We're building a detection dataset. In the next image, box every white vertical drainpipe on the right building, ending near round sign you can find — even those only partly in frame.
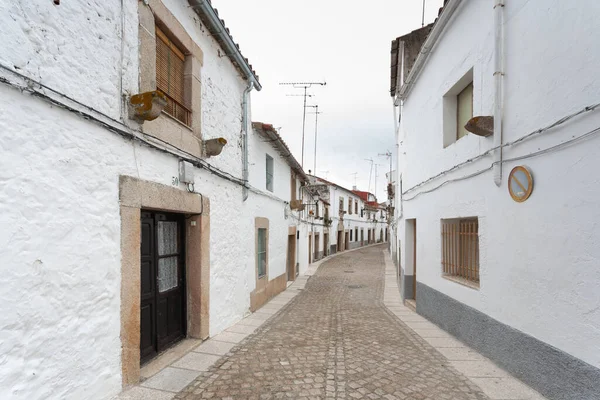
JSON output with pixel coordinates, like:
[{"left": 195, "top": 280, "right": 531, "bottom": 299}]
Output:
[{"left": 494, "top": 0, "right": 505, "bottom": 187}]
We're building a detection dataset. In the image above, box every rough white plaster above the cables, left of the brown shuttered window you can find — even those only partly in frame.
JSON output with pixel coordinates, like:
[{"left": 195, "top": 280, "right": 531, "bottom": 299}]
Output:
[{"left": 0, "top": 0, "right": 137, "bottom": 118}]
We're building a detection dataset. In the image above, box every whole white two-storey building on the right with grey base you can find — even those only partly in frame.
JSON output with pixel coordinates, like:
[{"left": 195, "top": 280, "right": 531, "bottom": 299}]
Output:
[{"left": 391, "top": 0, "right": 600, "bottom": 400}]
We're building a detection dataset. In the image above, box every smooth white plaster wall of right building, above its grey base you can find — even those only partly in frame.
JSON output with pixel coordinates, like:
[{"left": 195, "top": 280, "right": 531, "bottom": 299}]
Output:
[{"left": 398, "top": 0, "right": 600, "bottom": 367}]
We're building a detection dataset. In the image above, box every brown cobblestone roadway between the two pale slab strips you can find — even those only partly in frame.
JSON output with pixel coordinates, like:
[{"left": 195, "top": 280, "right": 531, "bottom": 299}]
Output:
[{"left": 175, "top": 246, "right": 487, "bottom": 400}]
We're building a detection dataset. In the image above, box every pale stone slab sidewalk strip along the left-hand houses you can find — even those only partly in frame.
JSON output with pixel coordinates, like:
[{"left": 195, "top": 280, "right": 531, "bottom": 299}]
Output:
[{"left": 113, "top": 275, "right": 310, "bottom": 400}]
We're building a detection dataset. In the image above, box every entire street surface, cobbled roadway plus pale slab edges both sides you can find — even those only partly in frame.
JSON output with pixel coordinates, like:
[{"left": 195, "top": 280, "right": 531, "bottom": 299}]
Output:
[{"left": 120, "top": 246, "right": 543, "bottom": 400}]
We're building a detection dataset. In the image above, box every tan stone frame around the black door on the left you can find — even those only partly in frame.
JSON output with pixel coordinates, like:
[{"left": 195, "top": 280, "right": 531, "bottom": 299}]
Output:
[{"left": 119, "top": 175, "right": 210, "bottom": 387}]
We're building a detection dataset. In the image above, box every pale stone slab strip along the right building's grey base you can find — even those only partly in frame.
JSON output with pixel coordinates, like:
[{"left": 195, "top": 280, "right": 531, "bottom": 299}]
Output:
[{"left": 383, "top": 251, "right": 545, "bottom": 400}]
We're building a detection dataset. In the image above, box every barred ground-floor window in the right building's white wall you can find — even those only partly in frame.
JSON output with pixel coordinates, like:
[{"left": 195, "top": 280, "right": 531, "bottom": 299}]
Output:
[{"left": 442, "top": 218, "right": 479, "bottom": 283}]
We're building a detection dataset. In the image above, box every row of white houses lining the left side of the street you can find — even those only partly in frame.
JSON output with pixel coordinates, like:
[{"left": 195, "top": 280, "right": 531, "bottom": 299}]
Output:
[{"left": 0, "top": 0, "right": 387, "bottom": 400}]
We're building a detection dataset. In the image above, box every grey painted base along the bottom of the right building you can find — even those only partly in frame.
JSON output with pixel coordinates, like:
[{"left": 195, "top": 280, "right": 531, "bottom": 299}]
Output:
[{"left": 420, "top": 282, "right": 600, "bottom": 400}]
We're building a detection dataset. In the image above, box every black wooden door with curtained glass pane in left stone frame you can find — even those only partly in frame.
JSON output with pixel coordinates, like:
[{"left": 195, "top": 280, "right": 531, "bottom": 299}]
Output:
[{"left": 140, "top": 211, "right": 186, "bottom": 362}]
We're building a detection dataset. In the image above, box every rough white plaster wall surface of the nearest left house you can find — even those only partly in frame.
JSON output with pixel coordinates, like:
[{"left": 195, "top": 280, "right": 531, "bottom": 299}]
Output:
[{"left": 0, "top": 0, "right": 282, "bottom": 400}]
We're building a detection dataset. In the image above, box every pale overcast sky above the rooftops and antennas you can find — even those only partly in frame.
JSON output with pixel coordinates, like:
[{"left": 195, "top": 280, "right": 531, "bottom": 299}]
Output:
[{"left": 212, "top": 0, "right": 443, "bottom": 202}]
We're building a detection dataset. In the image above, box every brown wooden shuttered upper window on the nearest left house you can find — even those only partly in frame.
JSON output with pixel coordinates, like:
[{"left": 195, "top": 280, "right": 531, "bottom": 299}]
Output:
[{"left": 156, "top": 27, "right": 191, "bottom": 126}]
